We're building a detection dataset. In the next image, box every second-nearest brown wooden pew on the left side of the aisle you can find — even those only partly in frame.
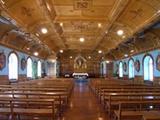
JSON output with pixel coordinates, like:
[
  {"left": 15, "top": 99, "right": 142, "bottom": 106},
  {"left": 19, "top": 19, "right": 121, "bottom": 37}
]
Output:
[{"left": 0, "top": 91, "right": 69, "bottom": 114}]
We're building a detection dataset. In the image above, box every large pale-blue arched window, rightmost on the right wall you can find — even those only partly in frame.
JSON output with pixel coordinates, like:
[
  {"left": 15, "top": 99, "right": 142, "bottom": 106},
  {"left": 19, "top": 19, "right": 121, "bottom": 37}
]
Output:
[{"left": 143, "top": 55, "right": 153, "bottom": 81}]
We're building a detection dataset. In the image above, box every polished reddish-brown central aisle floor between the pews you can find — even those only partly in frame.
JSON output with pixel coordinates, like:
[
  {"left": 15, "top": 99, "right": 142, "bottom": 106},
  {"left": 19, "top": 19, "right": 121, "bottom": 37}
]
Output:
[{"left": 62, "top": 82, "right": 109, "bottom": 120}]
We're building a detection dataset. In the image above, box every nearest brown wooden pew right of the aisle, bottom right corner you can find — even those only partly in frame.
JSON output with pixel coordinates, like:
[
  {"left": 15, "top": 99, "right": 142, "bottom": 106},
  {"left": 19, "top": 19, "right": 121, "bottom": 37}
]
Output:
[{"left": 114, "top": 100, "right": 160, "bottom": 120}]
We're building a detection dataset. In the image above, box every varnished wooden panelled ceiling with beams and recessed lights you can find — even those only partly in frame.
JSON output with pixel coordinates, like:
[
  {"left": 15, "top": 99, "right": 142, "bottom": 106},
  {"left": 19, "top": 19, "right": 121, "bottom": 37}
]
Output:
[{"left": 0, "top": 0, "right": 160, "bottom": 59}]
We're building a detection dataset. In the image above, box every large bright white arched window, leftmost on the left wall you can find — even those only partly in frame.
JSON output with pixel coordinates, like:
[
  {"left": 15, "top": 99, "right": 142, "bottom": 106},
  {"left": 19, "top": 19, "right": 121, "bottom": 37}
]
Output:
[{"left": 8, "top": 53, "right": 18, "bottom": 79}]
